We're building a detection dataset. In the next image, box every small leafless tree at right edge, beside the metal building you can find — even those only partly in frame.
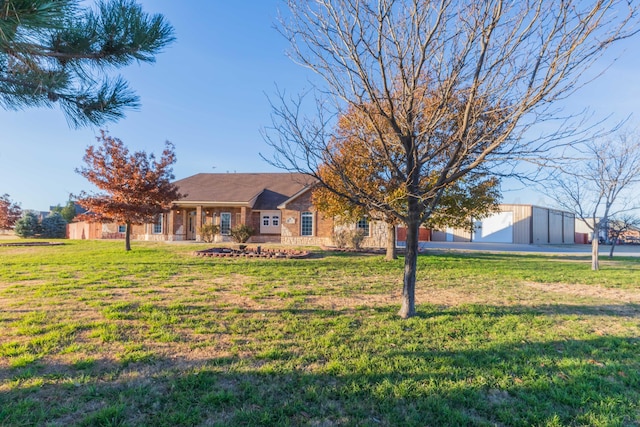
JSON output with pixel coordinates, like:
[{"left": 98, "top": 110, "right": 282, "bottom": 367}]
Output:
[{"left": 549, "top": 130, "right": 640, "bottom": 270}]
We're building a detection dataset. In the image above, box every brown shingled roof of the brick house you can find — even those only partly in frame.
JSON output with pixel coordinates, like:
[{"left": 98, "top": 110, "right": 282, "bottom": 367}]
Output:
[{"left": 175, "top": 173, "right": 314, "bottom": 210}]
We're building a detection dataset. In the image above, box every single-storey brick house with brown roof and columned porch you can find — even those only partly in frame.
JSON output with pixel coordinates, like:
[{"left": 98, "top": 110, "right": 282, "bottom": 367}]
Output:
[{"left": 67, "top": 173, "right": 386, "bottom": 247}]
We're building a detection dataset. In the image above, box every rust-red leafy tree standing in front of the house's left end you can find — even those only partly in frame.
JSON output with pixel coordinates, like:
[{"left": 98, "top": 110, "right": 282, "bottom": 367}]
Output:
[{"left": 76, "top": 130, "right": 183, "bottom": 251}]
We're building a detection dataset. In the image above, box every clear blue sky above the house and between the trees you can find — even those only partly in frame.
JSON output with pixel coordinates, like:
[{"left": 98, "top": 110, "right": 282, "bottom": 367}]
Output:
[{"left": 0, "top": 0, "right": 640, "bottom": 210}]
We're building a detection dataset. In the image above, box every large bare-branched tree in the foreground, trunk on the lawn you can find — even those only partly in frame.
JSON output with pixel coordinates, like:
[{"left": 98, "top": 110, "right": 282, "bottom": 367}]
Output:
[{"left": 265, "top": 0, "right": 638, "bottom": 317}]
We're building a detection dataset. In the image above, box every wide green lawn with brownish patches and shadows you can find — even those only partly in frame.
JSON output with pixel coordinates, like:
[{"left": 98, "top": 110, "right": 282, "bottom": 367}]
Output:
[{"left": 0, "top": 241, "right": 640, "bottom": 426}]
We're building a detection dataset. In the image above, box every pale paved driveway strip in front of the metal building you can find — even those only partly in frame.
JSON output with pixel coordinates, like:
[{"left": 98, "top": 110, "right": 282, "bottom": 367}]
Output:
[{"left": 410, "top": 242, "right": 640, "bottom": 258}]
